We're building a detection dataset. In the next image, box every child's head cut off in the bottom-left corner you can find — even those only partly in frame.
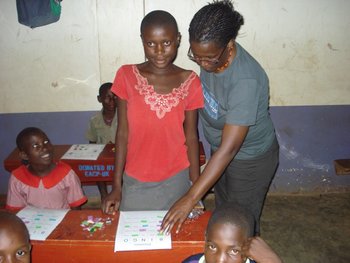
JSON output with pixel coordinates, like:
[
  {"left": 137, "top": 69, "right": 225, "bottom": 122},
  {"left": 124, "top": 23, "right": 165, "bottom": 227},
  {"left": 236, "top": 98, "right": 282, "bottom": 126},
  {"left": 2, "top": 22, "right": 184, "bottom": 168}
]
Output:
[{"left": 0, "top": 211, "right": 31, "bottom": 263}]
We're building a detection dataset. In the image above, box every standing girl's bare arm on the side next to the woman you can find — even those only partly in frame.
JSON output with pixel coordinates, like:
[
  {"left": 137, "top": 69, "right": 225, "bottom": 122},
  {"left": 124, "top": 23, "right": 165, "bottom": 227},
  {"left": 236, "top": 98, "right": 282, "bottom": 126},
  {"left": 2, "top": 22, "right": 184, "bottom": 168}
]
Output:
[{"left": 184, "top": 110, "right": 200, "bottom": 183}]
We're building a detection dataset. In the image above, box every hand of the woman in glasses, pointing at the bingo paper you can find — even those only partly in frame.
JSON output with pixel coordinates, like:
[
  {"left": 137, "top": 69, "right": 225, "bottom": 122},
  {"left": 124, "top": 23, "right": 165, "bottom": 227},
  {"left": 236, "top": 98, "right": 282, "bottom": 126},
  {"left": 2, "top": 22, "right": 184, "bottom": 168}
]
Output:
[{"left": 160, "top": 195, "right": 196, "bottom": 234}]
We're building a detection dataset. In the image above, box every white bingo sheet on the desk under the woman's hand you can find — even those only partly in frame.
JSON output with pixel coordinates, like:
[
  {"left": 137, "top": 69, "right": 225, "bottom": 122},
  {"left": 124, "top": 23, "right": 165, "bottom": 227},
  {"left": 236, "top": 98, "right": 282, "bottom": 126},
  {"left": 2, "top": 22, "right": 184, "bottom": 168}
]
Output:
[{"left": 114, "top": 211, "right": 171, "bottom": 251}]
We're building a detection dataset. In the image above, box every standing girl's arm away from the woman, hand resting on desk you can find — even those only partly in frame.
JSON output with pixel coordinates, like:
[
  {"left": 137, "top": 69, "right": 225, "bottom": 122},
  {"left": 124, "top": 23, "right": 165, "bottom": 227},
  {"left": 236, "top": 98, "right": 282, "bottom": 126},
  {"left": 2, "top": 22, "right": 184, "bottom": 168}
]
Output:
[{"left": 102, "top": 98, "right": 128, "bottom": 214}]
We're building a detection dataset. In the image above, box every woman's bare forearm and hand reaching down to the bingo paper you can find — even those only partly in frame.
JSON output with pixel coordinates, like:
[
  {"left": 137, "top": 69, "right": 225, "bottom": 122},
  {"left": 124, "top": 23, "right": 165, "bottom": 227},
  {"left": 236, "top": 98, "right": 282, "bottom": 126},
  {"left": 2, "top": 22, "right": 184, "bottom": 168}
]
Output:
[{"left": 161, "top": 124, "right": 249, "bottom": 233}]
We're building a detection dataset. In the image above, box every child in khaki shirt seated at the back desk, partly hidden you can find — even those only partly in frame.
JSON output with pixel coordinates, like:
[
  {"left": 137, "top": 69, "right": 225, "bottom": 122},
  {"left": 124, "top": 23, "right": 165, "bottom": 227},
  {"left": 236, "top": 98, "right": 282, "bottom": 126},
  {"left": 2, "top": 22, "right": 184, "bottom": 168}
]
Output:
[{"left": 86, "top": 82, "right": 118, "bottom": 200}]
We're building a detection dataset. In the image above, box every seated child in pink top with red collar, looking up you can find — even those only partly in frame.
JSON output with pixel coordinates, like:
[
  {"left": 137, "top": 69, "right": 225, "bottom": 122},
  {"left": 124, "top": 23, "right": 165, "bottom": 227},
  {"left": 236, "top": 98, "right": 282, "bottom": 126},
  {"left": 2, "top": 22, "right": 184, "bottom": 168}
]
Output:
[{"left": 6, "top": 127, "right": 87, "bottom": 210}]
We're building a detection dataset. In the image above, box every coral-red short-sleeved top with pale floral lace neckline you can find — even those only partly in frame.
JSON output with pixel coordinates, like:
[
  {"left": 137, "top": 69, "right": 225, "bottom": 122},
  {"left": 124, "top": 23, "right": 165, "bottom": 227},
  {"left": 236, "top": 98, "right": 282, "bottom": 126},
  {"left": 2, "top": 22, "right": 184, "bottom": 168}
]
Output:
[{"left": 112, "top": 65, "right": 204, "bottom": 182}]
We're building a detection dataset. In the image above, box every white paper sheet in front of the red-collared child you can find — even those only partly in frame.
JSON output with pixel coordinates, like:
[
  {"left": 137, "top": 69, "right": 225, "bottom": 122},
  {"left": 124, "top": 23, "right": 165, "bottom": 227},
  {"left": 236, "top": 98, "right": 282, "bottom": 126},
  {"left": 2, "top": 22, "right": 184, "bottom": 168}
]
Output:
[{"left": 17, "top": 206, "right": 69, "bottom": 240}]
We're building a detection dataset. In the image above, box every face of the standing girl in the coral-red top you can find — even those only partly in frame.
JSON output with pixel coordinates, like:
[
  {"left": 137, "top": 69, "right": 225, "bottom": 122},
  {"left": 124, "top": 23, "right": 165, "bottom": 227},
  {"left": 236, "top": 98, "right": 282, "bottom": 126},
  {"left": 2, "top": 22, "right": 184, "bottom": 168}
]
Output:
[{"left": 141, "top": 25, "right": 180, "bottom": 69}]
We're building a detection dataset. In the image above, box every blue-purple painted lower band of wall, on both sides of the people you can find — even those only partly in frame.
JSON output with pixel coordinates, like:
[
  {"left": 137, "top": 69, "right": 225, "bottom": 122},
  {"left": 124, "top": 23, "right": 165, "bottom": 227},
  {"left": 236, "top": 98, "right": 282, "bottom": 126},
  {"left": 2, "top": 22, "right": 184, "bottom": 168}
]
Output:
[{"left": 0, "top": 105, "right": 350, "bottom": 194}]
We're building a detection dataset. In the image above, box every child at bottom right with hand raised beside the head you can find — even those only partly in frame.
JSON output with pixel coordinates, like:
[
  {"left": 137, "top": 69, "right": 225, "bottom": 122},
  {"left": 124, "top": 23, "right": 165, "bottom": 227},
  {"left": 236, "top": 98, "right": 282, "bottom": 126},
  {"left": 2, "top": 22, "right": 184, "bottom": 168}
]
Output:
[{"left": 183, "top": 203, "right": 282, "bottom": 263}]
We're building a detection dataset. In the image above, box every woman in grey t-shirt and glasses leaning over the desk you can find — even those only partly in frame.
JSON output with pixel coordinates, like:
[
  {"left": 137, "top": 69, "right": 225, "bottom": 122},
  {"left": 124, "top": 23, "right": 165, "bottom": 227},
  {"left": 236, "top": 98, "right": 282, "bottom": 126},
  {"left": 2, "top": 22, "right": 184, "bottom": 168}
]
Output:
[{"left": 162, "top": 0, "right": 279, "bottom": 234}]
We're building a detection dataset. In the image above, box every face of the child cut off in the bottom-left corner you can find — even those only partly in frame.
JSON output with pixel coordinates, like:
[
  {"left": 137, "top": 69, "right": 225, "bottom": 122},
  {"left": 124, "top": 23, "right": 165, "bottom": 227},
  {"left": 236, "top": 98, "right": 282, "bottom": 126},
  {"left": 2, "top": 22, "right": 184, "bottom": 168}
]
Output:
[{"left": 0, "top": 226, "right": 30, "bottom": 263}]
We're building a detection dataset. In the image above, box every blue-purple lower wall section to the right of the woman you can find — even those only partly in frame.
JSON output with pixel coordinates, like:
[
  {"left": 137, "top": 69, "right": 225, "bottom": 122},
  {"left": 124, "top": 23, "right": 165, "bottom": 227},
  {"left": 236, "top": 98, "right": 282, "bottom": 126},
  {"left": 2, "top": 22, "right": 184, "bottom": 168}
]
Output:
[{"left": 270, "top": 105, "right": 350, "bottom": 192}]
